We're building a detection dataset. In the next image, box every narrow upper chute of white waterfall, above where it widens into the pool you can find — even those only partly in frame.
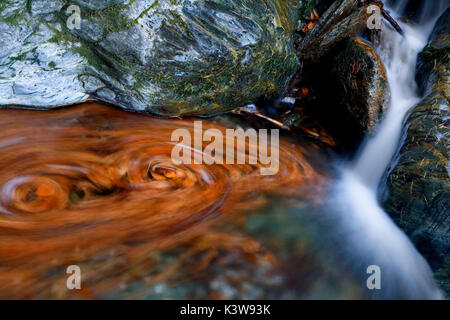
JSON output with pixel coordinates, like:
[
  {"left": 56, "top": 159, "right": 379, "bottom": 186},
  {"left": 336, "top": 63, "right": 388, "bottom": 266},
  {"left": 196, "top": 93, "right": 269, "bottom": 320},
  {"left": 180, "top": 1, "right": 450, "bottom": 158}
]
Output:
[{"left": 352, "top": 0, "right": 448, "bottom": 190}]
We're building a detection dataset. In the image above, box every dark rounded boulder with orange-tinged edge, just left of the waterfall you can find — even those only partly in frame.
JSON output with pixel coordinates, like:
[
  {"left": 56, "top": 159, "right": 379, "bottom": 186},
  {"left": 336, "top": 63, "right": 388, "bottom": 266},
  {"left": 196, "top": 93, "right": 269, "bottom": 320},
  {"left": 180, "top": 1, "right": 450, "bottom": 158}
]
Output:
[{"left": 282, "top": 37, "right": 390, "bottom": 151}]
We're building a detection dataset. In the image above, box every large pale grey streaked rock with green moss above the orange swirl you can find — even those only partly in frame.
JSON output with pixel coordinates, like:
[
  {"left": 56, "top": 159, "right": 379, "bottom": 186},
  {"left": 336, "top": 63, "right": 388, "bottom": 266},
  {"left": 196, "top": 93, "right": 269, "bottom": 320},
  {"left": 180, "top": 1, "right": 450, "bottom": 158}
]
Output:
[{"left": 0, "top": 0, "right": 308, "bottom": 116}]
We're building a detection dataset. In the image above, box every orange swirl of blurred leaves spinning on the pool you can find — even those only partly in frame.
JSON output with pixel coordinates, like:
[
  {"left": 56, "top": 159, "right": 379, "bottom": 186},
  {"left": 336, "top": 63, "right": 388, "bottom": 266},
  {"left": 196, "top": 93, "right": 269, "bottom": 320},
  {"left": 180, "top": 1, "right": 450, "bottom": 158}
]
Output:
[{"left": 0, "top": 104, "right": 321, "bottom": 298}]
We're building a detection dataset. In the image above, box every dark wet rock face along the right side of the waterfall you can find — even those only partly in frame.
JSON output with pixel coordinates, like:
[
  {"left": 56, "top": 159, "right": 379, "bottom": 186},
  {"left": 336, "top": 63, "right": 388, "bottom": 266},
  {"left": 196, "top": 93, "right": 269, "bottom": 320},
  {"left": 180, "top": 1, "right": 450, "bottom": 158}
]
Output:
[{"left": 384, "top": 9, "right": 450, "bottom": 294}]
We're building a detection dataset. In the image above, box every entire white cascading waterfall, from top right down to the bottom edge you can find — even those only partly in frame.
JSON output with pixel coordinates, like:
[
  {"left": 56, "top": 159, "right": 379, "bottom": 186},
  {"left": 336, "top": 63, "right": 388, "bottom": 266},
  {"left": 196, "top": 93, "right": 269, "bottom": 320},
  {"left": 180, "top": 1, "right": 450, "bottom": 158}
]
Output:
[{"left": 329, "top": 0, "right": 448, "bottom": 299}]
